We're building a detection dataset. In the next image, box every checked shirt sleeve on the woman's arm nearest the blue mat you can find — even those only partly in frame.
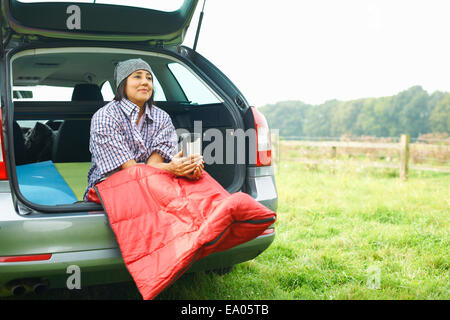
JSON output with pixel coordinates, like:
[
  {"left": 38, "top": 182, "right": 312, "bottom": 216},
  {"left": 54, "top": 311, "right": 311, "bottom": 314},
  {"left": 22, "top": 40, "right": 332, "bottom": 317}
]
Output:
[{"left": 89, "top": 109, "right": 133, "bottom": 175}]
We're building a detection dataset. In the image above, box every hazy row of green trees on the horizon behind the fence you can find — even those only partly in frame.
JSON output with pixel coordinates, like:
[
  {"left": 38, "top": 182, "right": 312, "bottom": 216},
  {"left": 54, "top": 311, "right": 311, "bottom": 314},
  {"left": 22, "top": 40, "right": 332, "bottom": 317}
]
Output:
[{"left": 258, "top": 86, "right": 450, "bottom": 138}]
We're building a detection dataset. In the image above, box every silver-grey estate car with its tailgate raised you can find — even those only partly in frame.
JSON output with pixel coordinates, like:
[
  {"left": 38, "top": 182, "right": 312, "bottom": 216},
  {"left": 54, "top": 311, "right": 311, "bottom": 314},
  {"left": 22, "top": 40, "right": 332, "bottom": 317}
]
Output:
[{"left": 0, "top": 0, "right": 277, "bottom": 297}]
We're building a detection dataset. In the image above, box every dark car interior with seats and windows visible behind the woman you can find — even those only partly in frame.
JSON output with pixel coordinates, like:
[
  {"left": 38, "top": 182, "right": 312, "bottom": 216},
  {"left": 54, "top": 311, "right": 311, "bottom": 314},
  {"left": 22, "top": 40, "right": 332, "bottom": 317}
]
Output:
[{"left": 12, "top": 48, "right": 236, "bottom": 206}]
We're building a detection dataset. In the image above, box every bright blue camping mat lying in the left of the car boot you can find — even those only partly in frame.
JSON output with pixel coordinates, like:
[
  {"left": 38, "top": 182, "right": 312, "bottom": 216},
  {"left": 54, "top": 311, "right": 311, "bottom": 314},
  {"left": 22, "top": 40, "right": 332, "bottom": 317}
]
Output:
[{"left": 16, "top": 161, "right": 77, "bottom": 205}]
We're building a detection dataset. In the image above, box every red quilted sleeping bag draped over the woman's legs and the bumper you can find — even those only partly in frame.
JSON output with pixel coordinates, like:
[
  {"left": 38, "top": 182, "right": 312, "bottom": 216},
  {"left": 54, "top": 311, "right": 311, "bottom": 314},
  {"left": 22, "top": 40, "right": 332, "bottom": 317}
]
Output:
[{"left": 88, "top": 164, "right": 276, "bottom": 299}]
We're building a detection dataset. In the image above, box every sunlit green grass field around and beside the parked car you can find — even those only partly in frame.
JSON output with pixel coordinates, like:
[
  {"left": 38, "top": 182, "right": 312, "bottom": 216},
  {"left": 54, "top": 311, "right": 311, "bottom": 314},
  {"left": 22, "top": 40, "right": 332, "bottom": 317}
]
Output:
[{"left": 7, "top": 162, "right": 450, "bottom": 300}]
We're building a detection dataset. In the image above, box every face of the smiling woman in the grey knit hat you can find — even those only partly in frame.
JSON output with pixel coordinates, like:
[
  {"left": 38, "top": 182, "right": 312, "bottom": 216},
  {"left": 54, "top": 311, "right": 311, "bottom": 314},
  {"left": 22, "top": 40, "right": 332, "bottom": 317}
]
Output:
[{"left": 125, "top": 70, "right": 153, "bottom": 107}]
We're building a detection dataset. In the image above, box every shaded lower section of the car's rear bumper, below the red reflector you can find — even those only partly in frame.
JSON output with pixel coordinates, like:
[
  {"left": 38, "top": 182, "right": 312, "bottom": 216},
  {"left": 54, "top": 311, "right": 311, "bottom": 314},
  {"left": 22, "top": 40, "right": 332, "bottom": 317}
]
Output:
[{"left": 0, "top": 232, "right": 275, "bottom": 297}]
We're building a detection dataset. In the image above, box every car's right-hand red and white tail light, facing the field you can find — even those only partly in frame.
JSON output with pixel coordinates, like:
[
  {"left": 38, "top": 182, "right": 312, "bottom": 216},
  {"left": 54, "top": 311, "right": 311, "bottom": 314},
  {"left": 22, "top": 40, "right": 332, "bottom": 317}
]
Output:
[{"left": 251, "top": 107, "right": 272, "bottom": 167}]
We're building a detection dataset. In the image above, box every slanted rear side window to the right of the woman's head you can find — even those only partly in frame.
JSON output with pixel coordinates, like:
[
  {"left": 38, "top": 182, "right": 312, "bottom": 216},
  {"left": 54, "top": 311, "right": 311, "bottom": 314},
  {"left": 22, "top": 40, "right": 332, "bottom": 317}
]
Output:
[{"left": 168, "top": 62, "right": 222, "bottom": 105}]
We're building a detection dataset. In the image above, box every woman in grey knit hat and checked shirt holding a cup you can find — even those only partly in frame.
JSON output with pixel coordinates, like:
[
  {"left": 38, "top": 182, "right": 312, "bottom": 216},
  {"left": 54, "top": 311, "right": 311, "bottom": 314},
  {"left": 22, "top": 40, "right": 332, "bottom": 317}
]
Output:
[{"left": 84, "top": 59, "right": 204, "bottom": 201}]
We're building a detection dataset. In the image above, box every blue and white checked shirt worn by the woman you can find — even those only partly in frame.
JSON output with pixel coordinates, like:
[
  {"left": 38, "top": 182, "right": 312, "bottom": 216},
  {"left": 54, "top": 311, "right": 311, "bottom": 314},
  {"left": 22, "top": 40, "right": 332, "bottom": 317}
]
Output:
[{"left": 84, "top": 99, "right": 178, "bottom": 201}]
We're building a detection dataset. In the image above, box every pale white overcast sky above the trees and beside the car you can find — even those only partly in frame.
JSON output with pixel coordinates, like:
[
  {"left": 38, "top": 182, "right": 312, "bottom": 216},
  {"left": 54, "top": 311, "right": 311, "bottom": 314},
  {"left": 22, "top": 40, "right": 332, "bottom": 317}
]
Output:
[{"left": 184, "top": 0, "right": 450, "bottom": 106}]
